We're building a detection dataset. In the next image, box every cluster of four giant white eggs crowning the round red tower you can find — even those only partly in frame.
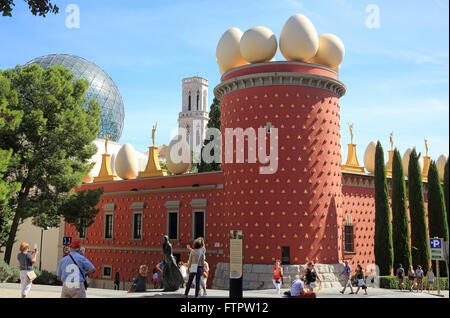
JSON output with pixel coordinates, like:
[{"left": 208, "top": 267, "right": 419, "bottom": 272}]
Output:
[{"left": 216, "top": 14, "right": 345, "bottom": 74}]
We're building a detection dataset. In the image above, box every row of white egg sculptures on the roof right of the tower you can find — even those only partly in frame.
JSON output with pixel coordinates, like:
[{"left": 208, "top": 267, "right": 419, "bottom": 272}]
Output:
[{"left": 364, "top": 141, "right": 448, "bottom": 181}]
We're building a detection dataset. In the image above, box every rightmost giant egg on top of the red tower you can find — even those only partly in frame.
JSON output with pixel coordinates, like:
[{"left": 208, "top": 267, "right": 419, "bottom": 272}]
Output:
[{"left": 308, "top": 33, "right": 345, "bottom": 68}]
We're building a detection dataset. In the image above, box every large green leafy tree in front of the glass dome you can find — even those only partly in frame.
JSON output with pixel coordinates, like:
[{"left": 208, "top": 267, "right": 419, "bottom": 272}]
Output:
[{"left": 0, "top": 64, "right": 101, "bottom": 263}]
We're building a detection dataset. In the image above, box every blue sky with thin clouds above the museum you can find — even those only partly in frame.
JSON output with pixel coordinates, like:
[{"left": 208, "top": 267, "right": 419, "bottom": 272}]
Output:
[{"left": 0, "top": 0, "right": 449, "bottom": 164}]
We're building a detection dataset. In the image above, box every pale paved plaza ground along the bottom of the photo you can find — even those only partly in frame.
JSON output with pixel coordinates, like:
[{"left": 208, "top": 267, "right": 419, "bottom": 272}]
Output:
[{"left": 0, "top": 283, "right": 449, "bottom": 299}]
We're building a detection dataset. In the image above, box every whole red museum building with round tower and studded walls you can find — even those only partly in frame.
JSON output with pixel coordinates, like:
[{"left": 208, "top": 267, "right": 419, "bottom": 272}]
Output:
[{"left": 65, "top": 62, "right": 428, "bottom": 287}]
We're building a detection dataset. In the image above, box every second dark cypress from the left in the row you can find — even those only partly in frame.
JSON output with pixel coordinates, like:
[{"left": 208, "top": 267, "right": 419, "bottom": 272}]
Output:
[{"left": 392, "top": 149, "right": 411, "bottom": 269}]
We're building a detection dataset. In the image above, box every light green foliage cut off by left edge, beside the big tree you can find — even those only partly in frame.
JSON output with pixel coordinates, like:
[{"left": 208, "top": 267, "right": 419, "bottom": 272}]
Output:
[{"left": 0, "top": 71, "right": 23, "bottom": 247}]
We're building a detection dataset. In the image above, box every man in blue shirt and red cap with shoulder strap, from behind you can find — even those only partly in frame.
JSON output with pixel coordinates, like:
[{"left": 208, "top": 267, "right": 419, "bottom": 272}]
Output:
[{"left": 56, "top": 241, "right": 95, "bottom": 298}]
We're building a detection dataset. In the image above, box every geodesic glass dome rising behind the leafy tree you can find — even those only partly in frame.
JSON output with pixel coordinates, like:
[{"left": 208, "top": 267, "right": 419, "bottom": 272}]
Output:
[{"left": 26, "top": 54, "right": 125, "bottom": 142}]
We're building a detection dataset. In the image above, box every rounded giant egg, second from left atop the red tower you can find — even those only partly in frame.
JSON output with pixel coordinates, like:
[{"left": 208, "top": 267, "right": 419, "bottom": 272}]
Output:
[{"left": 240, "top": 26, "right": 278, "bottom": 63}]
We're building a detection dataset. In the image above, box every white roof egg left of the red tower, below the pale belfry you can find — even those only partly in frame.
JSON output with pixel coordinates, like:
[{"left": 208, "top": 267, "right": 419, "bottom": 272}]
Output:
[{"left": 166, "top": 135, "right": 191, "bottom": 174}]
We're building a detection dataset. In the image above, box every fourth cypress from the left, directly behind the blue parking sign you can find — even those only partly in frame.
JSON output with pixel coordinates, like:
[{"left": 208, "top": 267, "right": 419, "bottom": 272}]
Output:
[{"left": 428, "top": 161, "right": 448, "bottom": 276}]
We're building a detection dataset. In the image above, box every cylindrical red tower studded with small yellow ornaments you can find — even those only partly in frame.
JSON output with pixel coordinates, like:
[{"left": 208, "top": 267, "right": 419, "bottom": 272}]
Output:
[{"left": 214, "top": 62, "right": 346, "bottom": 264}]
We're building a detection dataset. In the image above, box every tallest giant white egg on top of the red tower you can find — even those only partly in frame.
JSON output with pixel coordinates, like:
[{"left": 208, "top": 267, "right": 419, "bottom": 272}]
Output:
[{"left": 280, "top": 14, "right": 319, "bottom": 62}]
